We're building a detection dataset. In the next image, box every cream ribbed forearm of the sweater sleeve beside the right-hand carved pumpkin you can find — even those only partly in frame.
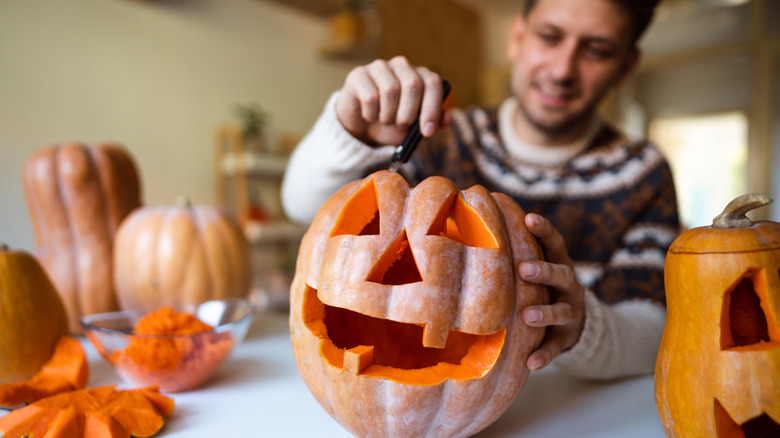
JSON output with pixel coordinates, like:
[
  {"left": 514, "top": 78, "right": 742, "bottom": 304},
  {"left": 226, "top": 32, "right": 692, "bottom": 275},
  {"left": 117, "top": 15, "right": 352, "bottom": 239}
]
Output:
[{"left": 553, "top": 290, "right": 666, "bottom": 380}]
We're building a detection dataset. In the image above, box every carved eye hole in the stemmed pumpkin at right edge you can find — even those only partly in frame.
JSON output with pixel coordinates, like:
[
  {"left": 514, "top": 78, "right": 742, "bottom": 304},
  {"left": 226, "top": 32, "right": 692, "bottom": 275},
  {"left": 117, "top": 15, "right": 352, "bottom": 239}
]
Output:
[{"left": 720, "top": 270, "right": 780, "bottom": 350}]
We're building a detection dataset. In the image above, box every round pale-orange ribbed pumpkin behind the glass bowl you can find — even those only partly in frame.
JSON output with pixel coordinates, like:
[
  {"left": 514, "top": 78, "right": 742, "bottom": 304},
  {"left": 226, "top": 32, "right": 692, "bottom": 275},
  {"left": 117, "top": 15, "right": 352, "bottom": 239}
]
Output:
[{"left": 114, "top": 198, "right": 252, "bottom": 311}]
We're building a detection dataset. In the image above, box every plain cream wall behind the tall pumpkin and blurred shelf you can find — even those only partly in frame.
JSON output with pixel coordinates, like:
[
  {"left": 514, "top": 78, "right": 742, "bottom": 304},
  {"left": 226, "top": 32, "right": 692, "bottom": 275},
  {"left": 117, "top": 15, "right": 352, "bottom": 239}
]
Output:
[{"left": 0, "top": 0, "right": 352, "bottom": 250}]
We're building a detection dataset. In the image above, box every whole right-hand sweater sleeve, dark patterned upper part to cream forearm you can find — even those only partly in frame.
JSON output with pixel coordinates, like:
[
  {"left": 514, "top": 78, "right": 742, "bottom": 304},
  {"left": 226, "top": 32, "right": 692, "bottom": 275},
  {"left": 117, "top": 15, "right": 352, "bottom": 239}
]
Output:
[{"left": 555, "top": 147, "right": 679, "bottom": 379}]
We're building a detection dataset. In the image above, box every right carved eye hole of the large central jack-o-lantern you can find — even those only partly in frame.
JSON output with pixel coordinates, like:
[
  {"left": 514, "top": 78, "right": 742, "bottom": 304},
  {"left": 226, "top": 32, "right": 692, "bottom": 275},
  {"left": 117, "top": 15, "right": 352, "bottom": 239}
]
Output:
[{"left": 427, "top": 192, "right": 498, "bottom": 248}]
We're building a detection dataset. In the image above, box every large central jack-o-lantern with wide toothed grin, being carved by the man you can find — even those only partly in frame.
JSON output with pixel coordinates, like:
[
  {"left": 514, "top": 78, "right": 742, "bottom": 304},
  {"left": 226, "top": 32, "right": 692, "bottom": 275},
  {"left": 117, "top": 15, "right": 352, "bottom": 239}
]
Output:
[{"left": 290, "top": 171, "right": 547, "bottom": 437}]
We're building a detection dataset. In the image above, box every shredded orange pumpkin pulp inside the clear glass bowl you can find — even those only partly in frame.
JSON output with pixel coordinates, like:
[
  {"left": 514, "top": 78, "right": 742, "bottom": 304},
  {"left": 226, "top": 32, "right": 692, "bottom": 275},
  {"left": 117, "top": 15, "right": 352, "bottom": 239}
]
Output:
[{"left": 111, "top": 307, "right": 233, "bottom": 392}]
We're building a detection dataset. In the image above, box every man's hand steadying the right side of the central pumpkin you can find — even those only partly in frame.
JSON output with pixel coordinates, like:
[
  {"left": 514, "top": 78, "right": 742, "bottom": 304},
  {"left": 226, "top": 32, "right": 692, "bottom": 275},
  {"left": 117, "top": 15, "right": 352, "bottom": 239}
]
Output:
[{"left": 520, "top": 213, "right": 585, "bottom": 370}]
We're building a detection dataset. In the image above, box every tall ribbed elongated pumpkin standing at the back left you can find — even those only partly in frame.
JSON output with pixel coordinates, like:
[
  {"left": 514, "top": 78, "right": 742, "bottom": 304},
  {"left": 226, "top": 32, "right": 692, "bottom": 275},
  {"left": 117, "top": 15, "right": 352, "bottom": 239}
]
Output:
[{"left": 24, "top": 142, "right": 141, "bottom": 333}]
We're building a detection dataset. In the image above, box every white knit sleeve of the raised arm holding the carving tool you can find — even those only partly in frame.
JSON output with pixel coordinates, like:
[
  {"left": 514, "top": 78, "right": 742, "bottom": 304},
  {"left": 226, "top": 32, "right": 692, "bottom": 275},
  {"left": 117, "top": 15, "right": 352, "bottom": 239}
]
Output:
[{"left": 281, "top": 91, "right": 395, "bottom": 224}]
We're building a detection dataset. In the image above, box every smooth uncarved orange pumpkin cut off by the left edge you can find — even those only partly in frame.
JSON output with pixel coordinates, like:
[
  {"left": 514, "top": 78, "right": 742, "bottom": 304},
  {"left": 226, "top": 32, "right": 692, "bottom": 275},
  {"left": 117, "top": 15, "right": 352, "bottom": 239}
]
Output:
[{"left": 0, "top": 244, "right": 68, "bottom": 384}]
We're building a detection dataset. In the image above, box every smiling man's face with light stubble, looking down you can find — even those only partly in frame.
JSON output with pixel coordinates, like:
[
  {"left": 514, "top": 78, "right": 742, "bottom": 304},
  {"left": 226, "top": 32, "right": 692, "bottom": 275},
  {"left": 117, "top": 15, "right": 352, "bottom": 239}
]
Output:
[{"left": 508, "top": 0, "right": 638, "bottom": 143}]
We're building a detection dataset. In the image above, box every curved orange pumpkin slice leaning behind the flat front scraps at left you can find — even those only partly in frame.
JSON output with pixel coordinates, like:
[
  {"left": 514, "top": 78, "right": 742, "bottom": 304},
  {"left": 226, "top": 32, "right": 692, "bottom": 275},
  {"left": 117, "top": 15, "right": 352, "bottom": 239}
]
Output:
[{"left": 0, "top": 336, "right": 89, "bottom": 406}]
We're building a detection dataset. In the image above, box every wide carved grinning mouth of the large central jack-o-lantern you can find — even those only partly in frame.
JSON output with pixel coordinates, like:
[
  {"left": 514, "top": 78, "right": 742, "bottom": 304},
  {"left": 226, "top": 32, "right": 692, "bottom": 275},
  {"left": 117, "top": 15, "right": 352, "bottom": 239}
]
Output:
[{"left": 302, "top": 285, "right": 506, "bottom": 385}]
